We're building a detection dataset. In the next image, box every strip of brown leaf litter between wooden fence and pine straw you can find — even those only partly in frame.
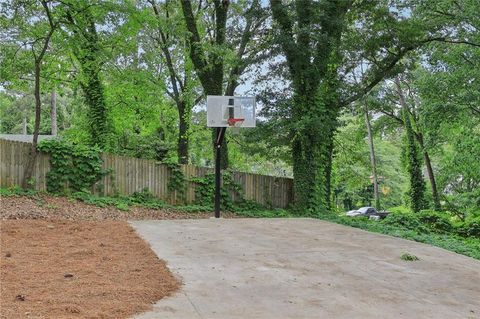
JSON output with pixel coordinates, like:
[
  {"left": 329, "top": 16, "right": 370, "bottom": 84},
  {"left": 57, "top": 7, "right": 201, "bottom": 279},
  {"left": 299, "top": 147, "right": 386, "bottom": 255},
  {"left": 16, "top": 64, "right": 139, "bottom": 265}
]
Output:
[{"left": 0, "top": 194, "right": 235, "bottom": 220}]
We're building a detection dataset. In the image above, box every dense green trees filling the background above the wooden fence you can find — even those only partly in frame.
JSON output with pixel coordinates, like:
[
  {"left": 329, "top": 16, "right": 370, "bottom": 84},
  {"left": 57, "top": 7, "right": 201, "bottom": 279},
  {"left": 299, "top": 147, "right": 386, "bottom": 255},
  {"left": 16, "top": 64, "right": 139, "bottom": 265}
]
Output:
[{"left": 0, "top": 0, "right": 480, "bottom": 216}]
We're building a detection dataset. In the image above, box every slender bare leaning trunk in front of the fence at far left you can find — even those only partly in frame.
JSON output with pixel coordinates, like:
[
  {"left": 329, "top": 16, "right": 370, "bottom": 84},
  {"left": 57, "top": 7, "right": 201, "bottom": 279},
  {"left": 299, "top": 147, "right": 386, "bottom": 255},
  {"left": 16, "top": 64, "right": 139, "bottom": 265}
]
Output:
[{"left": 22, "top": 60, "right": 42, "bottom": 188}]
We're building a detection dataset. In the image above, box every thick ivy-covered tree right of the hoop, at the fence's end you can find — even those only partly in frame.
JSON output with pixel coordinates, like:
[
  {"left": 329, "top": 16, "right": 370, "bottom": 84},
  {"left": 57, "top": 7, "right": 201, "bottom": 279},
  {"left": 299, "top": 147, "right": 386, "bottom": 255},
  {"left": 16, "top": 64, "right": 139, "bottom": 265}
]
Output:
[{"left": 270, "top": 0, "right": 433, "bottom": 214}]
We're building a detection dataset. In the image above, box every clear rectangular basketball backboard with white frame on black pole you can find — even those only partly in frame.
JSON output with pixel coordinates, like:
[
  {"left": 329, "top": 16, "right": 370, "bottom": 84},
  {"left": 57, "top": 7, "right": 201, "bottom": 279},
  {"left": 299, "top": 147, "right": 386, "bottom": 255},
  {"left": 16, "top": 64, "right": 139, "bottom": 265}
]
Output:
[{"left": 207, "top": 95, "right": 255, "bottom": 127}]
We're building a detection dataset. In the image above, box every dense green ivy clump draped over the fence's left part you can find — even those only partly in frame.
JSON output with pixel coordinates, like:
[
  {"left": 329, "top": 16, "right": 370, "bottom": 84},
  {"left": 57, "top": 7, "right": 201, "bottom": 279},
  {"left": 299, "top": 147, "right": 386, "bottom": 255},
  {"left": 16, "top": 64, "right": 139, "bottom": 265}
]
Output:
[{"left": 38, "top": 140, "right": 106, "bottom": 193}]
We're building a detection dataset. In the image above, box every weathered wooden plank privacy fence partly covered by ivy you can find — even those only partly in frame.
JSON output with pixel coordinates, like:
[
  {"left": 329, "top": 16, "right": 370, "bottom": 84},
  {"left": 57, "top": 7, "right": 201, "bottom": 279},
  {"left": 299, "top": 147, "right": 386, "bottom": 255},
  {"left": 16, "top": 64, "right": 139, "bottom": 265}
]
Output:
[{"left": 0, "top": 139, "right": 293, "bottom": 208}]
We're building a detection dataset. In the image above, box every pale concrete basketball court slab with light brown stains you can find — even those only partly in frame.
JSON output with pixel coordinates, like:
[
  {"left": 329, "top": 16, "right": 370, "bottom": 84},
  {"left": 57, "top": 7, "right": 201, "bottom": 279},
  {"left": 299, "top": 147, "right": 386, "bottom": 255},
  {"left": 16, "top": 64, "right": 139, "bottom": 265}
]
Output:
[{"left": 131, "top": 219, "right": 480, "bottom": 319}]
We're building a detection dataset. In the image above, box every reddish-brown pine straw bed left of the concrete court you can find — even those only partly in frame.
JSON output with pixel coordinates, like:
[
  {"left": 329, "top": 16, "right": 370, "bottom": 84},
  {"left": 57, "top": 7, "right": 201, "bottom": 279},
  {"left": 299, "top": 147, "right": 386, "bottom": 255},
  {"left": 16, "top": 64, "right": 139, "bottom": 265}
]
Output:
[{"left": 0, "top": 220, "right": 180, "bottom": 318}]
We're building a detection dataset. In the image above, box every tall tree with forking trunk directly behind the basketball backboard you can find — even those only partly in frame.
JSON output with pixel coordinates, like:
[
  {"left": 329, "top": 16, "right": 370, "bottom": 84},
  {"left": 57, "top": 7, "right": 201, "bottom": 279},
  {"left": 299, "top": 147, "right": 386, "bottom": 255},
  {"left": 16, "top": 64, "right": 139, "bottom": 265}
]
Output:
[{"left": 181, "top": 0, "right": 267, "bottom": 168}]
